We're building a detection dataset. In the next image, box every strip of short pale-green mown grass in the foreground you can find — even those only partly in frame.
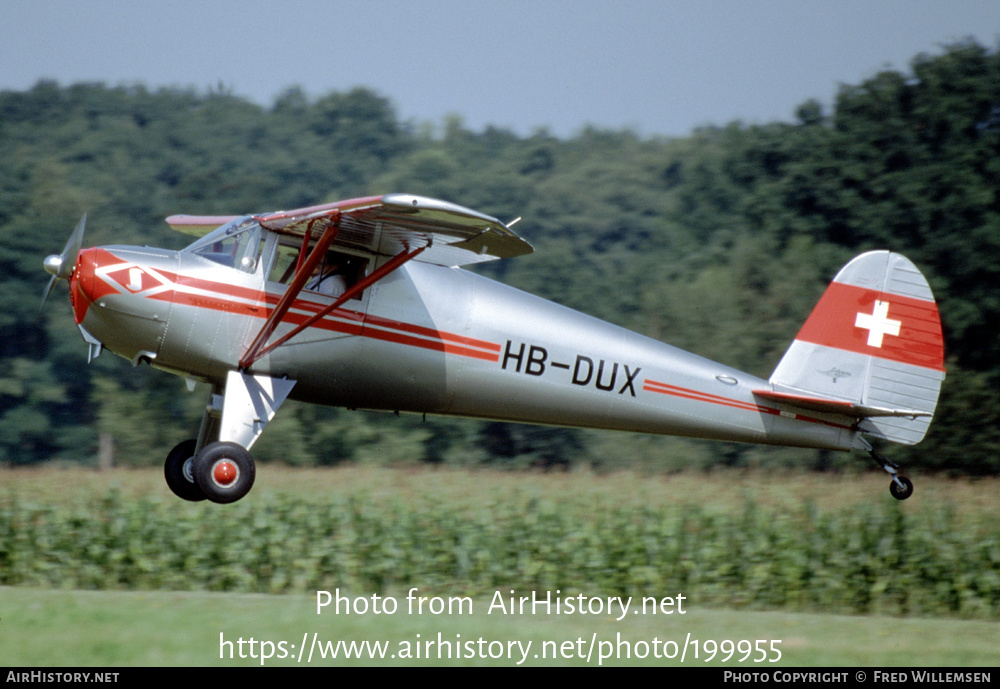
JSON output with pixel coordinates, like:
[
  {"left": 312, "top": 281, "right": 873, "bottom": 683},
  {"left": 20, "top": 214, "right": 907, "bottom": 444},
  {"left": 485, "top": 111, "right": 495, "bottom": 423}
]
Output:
[{"left": 0, "top": 588, "right": 1000, "bottom": 670}]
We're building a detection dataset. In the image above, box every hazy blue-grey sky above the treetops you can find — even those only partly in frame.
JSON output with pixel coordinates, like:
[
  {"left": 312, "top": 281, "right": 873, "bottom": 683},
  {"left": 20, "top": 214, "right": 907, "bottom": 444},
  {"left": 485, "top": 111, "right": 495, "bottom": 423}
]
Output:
[{"left": 0, "top": 0, "right": 1000, "bottom": 138}]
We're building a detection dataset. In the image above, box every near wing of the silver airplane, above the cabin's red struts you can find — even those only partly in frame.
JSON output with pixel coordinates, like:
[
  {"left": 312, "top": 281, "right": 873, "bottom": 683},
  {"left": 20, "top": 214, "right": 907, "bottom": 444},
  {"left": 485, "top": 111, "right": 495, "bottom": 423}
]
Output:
[{"left": 258, "top": 194, "right": 534, "bottom": 266}]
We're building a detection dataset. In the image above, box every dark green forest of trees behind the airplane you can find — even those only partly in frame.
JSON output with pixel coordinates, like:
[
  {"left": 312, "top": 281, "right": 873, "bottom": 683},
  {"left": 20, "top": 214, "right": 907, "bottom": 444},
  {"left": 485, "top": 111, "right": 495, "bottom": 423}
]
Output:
[{"left": 0, "top": 41, "right": 1000, "bottom": 475}]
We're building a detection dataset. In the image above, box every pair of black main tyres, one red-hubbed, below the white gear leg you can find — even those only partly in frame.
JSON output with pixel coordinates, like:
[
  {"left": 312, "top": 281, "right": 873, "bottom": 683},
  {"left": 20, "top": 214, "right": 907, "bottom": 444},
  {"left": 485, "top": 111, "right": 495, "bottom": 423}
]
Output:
[{"left": 163, "top": 438, "right": 257, "bottom": 503}]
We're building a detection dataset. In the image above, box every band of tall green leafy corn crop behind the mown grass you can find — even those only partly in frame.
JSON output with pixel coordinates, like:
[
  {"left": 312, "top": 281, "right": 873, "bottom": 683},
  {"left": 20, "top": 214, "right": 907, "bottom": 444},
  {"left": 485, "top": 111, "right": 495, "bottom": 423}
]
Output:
[{"left": 0, "top": 490, "right": 1000, "bottom": 618}]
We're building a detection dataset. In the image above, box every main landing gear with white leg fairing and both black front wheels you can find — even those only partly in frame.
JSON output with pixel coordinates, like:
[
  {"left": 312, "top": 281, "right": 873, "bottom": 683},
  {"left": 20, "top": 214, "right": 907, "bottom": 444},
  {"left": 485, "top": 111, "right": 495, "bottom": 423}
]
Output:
[{"left": 163, "top": 371, "right": 295, "bottom": 503}]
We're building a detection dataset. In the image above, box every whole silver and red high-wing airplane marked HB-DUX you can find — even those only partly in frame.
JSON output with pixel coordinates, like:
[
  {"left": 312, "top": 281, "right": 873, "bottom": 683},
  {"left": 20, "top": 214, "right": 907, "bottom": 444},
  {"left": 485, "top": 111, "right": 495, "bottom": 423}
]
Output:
[{"left": 45, "top": 194, "right": 945, "bottom": 503}]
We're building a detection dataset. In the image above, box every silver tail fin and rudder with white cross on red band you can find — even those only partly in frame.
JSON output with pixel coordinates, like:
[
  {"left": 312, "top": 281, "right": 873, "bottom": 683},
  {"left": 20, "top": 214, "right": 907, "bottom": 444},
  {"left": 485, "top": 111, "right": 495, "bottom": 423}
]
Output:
[{"left": 770, "top": 251, "right": 945, "bottom": 445}]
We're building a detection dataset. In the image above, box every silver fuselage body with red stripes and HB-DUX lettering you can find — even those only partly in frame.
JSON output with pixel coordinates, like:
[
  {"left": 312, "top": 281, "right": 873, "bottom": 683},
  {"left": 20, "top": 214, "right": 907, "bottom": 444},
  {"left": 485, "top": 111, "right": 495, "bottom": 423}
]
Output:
[{"left": 71, "top": 243, "right": 855, "bottom": 450}]
